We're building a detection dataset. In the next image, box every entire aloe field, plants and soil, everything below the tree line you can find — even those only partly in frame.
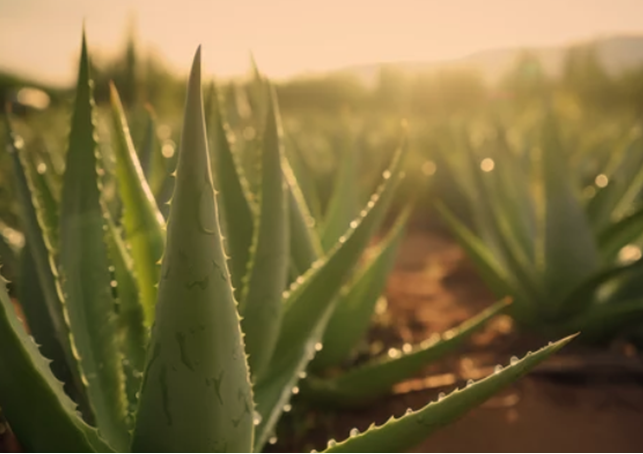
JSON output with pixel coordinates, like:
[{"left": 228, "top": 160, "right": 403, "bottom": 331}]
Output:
[{"left": 0, "top": 30, "right": 643, "bottom": 452}]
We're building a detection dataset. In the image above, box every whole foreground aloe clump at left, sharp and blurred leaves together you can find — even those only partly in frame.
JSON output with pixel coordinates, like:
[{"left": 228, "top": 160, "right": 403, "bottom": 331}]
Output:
[{"left": 0, "top": 33, "right": 577, "bottom": 452}]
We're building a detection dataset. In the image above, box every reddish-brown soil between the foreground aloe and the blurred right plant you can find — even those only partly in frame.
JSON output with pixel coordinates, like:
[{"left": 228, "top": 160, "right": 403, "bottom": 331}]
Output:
[{"left": 269, "top": 229, "right": 643, "bottom": 452}]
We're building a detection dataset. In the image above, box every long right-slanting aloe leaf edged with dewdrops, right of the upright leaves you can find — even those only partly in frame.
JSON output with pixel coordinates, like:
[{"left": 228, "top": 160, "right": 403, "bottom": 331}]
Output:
[{"left": 255, "top": 133, "right": 408, "bottom": 451}]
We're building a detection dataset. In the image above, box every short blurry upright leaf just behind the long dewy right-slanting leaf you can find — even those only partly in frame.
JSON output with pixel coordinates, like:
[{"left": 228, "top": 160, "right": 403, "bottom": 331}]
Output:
[{"left": 322, "top": 129, "right": 359, "bottom": 251}]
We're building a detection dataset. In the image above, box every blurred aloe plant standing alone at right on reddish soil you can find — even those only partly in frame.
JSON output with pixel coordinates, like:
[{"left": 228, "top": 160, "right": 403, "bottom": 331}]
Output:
[{"left": 438, "top": 111, "right": 643, "bottom": 342}]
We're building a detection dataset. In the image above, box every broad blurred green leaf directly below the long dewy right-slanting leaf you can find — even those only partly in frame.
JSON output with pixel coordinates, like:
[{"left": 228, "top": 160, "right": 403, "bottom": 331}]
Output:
[{"left": 311, "top": 206, "right": 411, "bottom": 370}]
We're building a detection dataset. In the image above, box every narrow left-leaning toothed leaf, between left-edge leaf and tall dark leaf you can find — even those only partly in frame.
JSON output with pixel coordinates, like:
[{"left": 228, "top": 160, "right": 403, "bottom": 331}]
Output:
[{"left": 6, "top": 113, "right": 92, "bottom": 414}]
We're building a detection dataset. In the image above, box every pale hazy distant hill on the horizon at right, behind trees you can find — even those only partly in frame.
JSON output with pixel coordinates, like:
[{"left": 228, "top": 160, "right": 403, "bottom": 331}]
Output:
[{"left": 333, "top": 36, "right": 643, "bottom": 85}]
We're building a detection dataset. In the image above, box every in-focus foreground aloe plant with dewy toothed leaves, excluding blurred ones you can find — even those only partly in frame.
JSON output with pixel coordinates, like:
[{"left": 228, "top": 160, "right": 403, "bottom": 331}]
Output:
[{"left": 0, "top": 32, "right": 569, "bottom": 452}]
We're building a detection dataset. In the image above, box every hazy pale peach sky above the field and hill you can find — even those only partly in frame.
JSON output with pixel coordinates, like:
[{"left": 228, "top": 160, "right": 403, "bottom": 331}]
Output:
[{"left": 0, "top": 0, "right": 643, "bottom": 83}]
